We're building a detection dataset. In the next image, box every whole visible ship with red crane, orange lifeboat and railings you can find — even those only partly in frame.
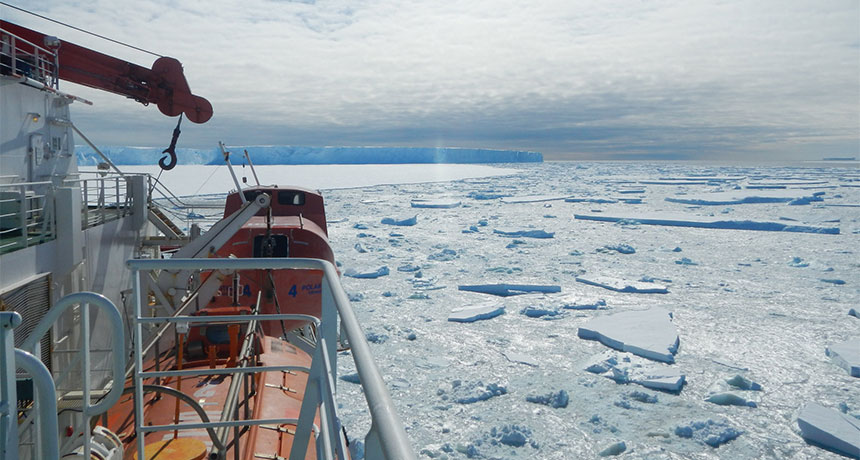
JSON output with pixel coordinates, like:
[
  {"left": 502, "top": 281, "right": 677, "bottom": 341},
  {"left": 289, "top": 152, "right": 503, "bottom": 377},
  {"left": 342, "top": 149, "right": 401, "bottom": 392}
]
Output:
[{"left": 0, "top": 21, "right": 414, "bottom": 459}]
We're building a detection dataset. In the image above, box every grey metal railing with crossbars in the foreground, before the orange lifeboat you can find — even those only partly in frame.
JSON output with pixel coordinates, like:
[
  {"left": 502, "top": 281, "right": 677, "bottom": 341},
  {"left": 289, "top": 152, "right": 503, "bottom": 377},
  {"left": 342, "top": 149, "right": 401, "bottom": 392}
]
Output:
[{"left": 128, "top": 258, "right": 415, "bottom": 460}]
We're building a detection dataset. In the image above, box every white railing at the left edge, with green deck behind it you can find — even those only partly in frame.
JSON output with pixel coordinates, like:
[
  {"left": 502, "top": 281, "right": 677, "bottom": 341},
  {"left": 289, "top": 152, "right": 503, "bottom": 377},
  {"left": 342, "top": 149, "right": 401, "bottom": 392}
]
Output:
[{"left": 0, "top": 182, "right": 57, "bottom": 254}]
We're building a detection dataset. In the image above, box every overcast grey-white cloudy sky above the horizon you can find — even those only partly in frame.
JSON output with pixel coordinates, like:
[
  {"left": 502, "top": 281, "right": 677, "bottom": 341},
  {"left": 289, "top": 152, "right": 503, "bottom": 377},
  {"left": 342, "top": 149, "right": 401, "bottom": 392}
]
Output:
[{"left": 0, "top": 0, "right": 860, "bottom": 161}]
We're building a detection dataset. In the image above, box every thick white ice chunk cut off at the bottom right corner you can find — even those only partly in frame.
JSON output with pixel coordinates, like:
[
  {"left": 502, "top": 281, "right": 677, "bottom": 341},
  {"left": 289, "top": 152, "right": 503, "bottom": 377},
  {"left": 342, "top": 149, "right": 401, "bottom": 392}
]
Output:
[{"left": 797, "top": 402, "right": 860, "bottom": 458}]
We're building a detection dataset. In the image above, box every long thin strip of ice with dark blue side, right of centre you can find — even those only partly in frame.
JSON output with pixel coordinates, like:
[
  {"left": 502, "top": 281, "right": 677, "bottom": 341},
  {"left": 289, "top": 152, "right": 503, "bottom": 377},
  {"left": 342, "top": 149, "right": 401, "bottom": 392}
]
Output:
[{"left": 573, "top": 214, "right": 839, "bottom": 235}]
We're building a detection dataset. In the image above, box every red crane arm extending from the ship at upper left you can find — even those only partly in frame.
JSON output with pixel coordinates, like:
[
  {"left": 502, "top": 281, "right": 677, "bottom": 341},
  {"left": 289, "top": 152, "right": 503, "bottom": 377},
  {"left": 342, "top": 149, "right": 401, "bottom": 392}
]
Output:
[{"left": 0, "top": 20, "right": 212, "bottom": 123}]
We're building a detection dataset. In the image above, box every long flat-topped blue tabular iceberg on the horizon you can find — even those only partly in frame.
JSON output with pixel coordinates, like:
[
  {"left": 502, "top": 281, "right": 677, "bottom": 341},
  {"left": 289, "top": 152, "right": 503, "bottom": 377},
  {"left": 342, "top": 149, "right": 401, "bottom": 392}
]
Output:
[{"left": 75, "top": 145, "right": 543, "bottom": 166}]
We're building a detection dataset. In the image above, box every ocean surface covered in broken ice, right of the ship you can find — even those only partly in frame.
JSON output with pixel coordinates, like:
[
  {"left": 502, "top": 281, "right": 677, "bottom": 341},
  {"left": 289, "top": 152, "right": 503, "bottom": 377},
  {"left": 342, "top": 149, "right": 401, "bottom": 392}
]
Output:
[{"left": 138, "top": 162, "right": 860, "bottom": 459}]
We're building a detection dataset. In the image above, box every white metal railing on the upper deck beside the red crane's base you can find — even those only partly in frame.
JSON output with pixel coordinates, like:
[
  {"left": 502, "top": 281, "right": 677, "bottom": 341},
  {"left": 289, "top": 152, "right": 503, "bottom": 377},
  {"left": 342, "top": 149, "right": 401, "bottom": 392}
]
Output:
[{"left": 0, "top": 23, "right": 59, "bottom": 89}]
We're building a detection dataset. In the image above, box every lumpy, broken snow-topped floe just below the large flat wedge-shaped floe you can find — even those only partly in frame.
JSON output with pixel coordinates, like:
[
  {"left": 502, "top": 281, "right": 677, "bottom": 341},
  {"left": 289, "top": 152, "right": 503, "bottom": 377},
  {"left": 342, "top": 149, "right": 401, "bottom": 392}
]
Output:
[{"left": 585, "top": 352, "right": 686, "bottom": 393}]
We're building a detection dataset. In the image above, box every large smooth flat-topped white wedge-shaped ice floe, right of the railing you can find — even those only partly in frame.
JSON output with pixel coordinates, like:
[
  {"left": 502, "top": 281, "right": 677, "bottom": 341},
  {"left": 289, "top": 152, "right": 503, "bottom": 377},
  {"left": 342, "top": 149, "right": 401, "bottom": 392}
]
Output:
[{"left": 577, "top": 308, "right": 680, "bottom": 363}]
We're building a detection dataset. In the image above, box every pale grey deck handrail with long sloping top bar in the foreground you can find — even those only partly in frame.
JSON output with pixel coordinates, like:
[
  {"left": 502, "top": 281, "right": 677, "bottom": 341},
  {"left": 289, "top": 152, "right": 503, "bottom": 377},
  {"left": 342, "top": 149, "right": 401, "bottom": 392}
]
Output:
[{"left": 127, "top": 258, "right": 416, "bottom": 460}]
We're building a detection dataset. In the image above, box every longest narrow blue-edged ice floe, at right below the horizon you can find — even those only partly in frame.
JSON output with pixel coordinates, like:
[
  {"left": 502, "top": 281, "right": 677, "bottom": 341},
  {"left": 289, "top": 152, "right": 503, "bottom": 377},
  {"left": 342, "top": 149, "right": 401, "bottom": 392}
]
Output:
[{"left": 573, "top": 213, "right": 839, "bottom": 235}]
